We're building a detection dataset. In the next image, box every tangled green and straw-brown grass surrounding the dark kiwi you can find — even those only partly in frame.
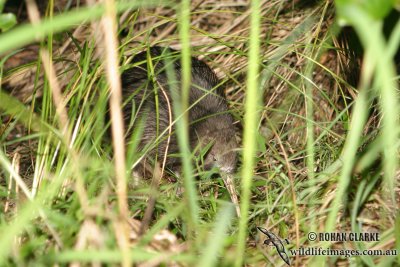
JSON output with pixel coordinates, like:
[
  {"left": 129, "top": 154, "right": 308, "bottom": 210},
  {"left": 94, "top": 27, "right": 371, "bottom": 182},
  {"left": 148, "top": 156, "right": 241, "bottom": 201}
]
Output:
[{"left": 0, "top": 1, "right": 400, "bottom": 266}]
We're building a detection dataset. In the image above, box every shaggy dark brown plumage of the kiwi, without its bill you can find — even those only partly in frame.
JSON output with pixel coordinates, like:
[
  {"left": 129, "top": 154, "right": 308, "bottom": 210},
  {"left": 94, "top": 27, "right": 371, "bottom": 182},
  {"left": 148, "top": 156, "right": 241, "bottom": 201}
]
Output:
[{"left": 122, "top": 47, "right": 237, "bottom": 172}]
